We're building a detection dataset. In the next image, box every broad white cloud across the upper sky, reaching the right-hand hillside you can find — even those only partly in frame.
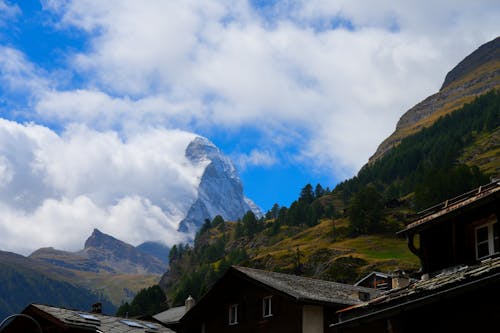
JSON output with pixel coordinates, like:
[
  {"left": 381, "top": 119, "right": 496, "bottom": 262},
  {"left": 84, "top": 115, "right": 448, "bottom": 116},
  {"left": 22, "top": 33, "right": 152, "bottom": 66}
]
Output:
[{"left": 33, "top": 0, "right": 499, "bottom": 174}]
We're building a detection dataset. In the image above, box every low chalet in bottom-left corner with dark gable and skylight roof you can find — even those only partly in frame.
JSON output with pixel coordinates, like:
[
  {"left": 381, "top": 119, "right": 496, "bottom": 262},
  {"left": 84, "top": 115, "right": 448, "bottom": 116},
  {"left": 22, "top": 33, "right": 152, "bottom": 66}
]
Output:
[{"left": 1, "top": 304, "right": 174, "bottom": 333}]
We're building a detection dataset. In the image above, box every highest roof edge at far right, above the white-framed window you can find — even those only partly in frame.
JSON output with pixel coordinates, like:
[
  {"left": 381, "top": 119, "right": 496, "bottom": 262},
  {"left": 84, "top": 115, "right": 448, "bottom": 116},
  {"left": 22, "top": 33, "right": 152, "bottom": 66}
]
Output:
[{"left": 400, "top": 180, "right": 500, "bottom": 233}]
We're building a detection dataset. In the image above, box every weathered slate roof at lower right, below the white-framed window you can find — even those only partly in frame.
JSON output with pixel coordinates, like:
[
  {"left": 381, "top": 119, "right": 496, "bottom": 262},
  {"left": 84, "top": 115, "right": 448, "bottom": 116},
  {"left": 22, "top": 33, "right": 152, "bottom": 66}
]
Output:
[{"left": 333, "top": 257, "right": 500, "bottom": 326}]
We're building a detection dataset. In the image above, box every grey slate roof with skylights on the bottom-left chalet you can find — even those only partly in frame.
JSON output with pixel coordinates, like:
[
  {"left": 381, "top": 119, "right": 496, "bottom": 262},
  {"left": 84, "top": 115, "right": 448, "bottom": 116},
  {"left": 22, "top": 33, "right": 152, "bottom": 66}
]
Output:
[{"left": 23, "top": 304, "right": 174, "bottom": 333}]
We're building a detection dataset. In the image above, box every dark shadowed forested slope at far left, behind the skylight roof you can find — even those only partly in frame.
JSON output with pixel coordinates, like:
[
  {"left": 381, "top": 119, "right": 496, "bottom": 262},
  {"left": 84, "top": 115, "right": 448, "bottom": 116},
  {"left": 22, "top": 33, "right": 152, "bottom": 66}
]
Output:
[{"left": 0, "top": 251, "right": 116, "bottom": 320}]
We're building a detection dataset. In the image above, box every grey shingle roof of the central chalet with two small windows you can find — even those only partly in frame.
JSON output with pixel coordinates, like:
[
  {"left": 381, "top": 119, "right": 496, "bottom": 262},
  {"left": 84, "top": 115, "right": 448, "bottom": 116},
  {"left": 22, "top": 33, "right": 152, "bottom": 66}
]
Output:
[{"left": 233, "top": 266, "right": 380, "bottom": 305}]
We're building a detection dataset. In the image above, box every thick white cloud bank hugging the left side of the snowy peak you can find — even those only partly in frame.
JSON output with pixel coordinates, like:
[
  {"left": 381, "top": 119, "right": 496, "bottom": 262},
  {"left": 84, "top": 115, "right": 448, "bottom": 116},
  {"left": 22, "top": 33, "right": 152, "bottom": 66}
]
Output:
[{"left": 0, "top": 119, "right": 204, "bottom": 253}]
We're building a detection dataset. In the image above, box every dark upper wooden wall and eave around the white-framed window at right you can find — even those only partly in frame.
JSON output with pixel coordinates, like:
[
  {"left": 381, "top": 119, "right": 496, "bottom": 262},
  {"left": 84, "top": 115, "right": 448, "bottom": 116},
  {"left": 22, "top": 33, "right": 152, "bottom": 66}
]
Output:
[{"left": 403, "top": 183, "right": 500, "bottom": 275}]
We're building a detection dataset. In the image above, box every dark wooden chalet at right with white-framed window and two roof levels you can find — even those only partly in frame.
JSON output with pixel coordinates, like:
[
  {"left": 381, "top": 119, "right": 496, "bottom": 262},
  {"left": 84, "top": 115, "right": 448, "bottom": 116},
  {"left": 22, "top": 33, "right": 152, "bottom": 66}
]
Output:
[{"left": 330, "top": 181, "right": 500, "bottom": 333}]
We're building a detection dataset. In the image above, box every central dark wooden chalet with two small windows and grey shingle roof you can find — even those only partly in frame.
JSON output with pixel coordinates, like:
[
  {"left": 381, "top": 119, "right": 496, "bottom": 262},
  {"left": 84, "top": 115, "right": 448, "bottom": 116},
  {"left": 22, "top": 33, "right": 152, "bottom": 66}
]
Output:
[{"left": 166, "top": 267, "right": 379, "bottom": 333}]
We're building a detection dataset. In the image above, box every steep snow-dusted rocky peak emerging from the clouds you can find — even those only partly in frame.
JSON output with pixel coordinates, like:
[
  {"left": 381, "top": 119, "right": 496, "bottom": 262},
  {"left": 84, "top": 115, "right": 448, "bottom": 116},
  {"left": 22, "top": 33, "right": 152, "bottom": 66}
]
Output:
[{"left": 179, "top": 137, "right": 262, "bottom": 234}]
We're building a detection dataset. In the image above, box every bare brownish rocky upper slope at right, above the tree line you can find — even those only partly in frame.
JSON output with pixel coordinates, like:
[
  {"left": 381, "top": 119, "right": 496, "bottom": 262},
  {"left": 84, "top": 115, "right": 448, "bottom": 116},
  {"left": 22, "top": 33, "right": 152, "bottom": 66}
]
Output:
[{"left": 370, "top": 37, "right": 500, "bottom": 163}]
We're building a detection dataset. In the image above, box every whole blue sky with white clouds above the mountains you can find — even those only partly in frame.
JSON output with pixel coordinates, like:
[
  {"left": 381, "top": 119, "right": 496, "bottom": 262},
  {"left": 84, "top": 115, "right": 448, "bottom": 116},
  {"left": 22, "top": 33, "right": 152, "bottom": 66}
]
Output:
[{"left": 0, "top": 0, "right": 500, "bottom": 254}]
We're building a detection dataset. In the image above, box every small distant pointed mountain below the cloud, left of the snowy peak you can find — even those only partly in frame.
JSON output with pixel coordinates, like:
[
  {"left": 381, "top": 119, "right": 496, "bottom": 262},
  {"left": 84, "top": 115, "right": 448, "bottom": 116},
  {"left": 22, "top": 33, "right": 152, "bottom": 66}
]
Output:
[{"left": 29, "top": 229, "right": 167, "bottom": 274}]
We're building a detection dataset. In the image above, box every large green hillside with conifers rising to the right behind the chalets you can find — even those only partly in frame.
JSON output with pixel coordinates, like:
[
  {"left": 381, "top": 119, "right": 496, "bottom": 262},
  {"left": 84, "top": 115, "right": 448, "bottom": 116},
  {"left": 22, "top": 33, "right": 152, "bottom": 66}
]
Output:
[{"left": 156, "top": 38, "right": 500, "bottom": 305}]
